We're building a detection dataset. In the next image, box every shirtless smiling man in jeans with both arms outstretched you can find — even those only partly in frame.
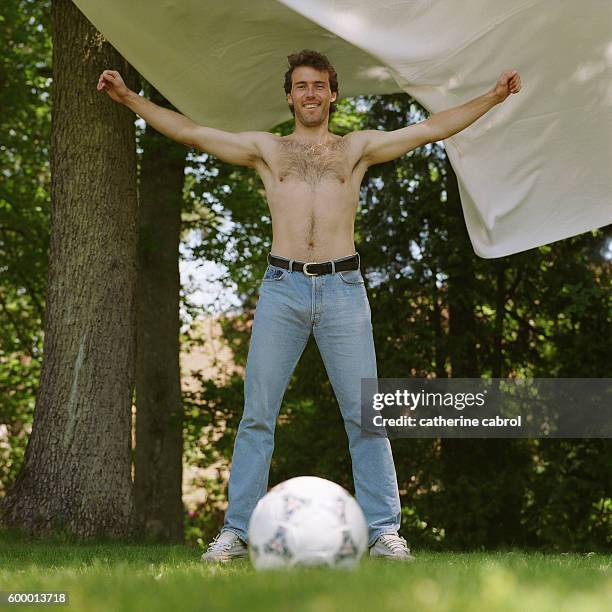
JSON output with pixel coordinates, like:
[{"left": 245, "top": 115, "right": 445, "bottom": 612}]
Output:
[{"left": 97, "top": 50, "right": 521, "bottom": 562}]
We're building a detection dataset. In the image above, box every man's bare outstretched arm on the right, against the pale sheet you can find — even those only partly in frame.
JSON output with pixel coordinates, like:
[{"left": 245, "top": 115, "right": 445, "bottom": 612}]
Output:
[{"left": 355, "top": 70, "right": 521, "bottom": 166}]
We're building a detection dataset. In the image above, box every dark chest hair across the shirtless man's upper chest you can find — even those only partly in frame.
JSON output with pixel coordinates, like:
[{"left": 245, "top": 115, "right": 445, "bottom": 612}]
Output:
[{"left": 278, "top": 138, "right": 348, "bottom": 185}]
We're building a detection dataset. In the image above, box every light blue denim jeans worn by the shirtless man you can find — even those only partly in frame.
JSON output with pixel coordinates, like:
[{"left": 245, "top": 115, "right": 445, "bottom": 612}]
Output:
[{"left": 222, "top": 251, "right": 401, "bottom": 546}]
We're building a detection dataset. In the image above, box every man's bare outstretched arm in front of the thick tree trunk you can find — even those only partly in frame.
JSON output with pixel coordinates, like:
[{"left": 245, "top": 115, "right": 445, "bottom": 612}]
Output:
[{"left": 97, "top": 70, "right": 266, "bottom": 167}]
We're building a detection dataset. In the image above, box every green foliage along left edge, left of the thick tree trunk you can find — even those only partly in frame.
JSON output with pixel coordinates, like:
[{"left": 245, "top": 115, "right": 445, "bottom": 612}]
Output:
[{"left": 0, "top": 0, "right": 51, "bottom": 496}]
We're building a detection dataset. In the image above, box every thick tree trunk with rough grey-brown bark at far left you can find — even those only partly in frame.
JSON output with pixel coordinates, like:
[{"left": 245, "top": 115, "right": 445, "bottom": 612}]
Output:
[{"left": 2, "top": 0, "right": 137, "bottom": 538}]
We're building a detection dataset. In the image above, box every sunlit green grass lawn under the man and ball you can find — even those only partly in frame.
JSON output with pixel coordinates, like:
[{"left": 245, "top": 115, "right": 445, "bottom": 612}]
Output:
[{"left": 0, "top": 535, "right": 612, "bottom": 612}]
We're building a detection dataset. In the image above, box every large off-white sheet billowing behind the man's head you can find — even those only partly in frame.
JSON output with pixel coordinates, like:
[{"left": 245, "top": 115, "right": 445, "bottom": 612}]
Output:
[{"left": 75, "top": 0, "right": 612, "bottom": 258}]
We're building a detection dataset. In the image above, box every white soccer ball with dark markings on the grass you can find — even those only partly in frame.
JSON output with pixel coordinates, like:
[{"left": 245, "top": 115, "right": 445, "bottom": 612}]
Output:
[{"left": 248, "top": 476, "right": 368, "bottom": 570}]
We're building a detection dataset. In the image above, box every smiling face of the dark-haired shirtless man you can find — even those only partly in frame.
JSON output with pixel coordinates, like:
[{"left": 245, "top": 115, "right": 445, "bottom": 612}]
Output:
[{"left": 287, "top": 66, "right": 336, "bottom": 127}]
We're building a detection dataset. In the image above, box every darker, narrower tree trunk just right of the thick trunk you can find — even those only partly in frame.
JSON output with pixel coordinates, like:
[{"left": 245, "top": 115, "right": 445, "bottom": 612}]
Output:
[{"left": 134, "top": 87, "right": 187, "bottom": 542}]
